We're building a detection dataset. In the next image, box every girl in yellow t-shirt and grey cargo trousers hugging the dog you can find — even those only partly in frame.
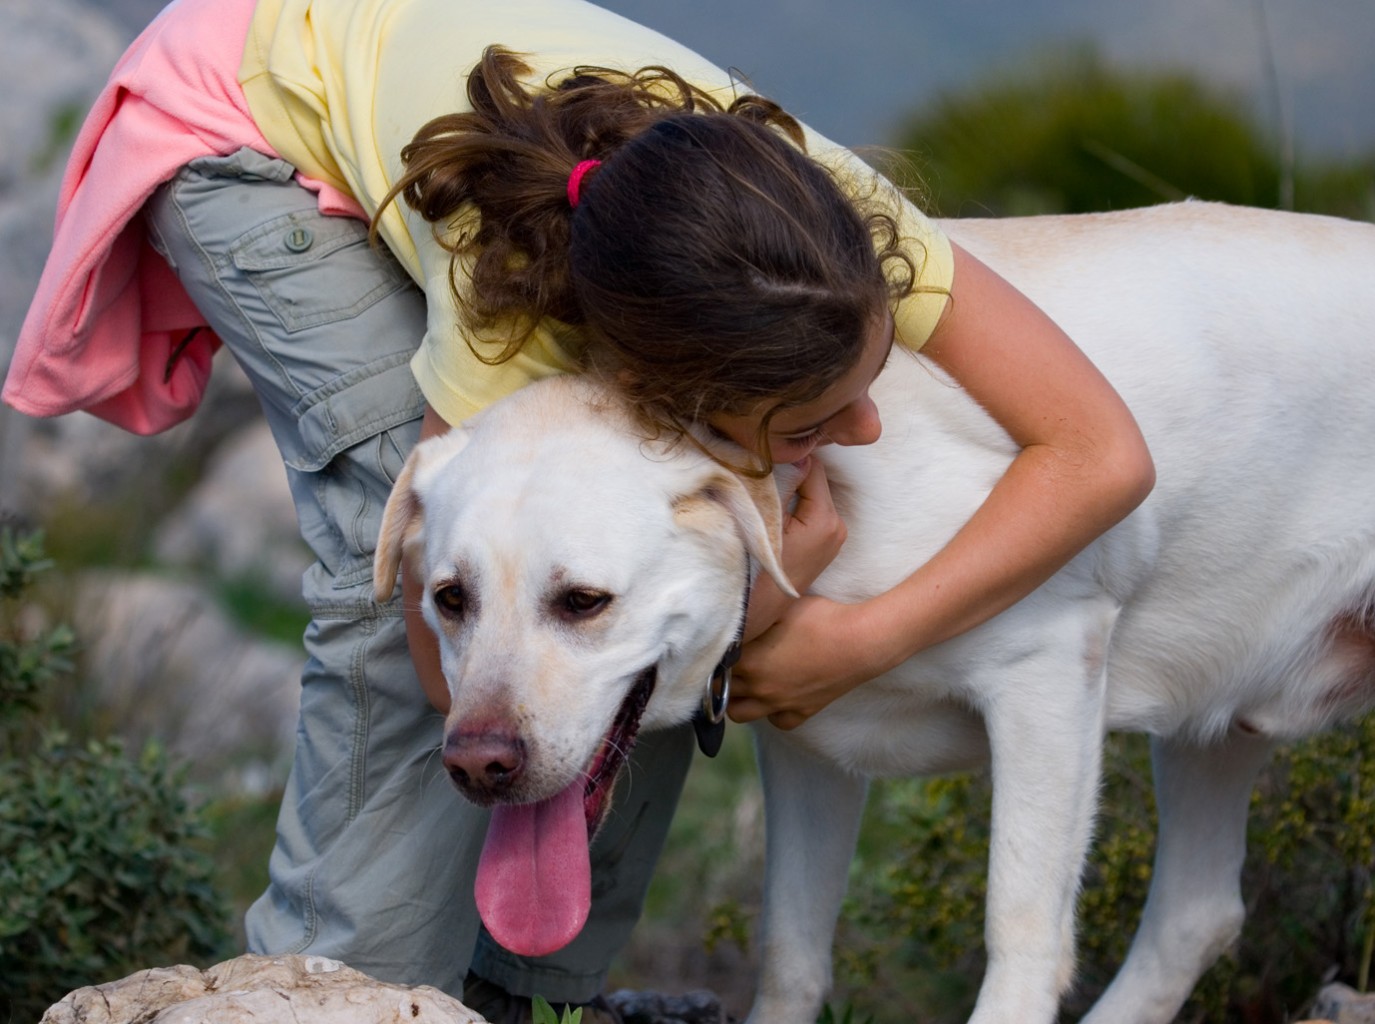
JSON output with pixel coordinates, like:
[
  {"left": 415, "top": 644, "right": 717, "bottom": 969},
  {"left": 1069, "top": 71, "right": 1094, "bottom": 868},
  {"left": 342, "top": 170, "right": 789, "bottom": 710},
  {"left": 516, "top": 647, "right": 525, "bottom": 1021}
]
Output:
[{"left": 4, "top": 0, "right": 1152, "bottom": 1020}]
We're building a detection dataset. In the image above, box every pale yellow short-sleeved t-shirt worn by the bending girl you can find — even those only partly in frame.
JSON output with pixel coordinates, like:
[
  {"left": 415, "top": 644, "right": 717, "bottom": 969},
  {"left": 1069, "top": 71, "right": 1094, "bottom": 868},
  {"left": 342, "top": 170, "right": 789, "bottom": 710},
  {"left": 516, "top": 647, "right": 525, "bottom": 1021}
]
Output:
[{"left": 239, "top": 0, "right": 953, "bottom": 423}]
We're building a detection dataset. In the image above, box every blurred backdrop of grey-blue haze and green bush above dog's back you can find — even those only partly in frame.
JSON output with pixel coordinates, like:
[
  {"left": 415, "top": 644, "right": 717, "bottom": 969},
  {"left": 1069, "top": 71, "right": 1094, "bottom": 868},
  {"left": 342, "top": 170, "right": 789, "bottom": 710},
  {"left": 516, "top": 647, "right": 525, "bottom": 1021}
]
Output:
[{"left": 64, "top": 0, "right": 1375, "bottom": 217}]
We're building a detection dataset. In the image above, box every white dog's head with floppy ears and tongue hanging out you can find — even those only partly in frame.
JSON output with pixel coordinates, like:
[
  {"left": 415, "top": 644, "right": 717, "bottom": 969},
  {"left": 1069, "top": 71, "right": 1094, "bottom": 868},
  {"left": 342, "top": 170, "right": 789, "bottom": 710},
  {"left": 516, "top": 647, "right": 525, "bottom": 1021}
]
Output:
[{"left": 375, "top": 377, "right": 791, "bottom": 955}]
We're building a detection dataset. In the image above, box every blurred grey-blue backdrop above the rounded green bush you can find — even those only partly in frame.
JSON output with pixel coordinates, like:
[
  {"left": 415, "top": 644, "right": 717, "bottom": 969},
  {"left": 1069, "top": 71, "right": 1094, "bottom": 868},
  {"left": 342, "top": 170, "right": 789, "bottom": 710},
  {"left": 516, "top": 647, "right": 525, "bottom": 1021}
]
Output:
[{"left": 98, "top": 0, "right": 1375, "bottom": 157}]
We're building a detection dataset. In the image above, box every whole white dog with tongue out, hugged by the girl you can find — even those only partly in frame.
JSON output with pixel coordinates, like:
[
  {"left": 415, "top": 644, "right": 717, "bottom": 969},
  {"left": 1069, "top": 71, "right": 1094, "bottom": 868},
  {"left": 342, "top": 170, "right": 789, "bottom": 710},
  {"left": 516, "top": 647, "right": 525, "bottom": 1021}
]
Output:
[{"left": 377, "top": 203, "right": 1375, "bottom": 1024}]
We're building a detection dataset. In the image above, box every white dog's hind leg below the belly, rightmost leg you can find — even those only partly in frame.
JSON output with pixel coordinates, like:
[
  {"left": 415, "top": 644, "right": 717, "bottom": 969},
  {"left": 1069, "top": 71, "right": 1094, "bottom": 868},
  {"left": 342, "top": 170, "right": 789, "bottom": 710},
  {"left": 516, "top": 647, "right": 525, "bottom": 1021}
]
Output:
[{"left": 1084, "top": 731, "right": 1275, "bottom": 1024}]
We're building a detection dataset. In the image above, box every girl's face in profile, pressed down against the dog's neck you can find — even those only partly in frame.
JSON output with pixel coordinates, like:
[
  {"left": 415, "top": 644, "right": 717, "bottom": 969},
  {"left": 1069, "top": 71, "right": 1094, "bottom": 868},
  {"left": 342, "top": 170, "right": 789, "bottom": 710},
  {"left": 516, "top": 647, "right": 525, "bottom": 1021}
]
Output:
[{"left": 707, "top": 313, "right": 892, "bottom": 463}]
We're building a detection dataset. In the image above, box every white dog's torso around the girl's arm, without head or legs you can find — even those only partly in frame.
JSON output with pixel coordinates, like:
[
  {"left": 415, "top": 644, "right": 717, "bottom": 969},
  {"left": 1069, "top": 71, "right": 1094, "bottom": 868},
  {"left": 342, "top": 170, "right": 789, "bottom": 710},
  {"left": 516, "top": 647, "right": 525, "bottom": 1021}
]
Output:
[{"left": 818, "top": 203, "right": 1375, "bottom": 753}]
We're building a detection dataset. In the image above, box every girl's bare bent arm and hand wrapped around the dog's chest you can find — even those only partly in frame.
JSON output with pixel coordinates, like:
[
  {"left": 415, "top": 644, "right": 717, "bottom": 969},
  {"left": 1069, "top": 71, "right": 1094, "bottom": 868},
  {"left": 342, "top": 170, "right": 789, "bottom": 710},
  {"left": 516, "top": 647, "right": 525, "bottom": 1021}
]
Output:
[{"left": 730, "top": 241, "right": 1155, "bottom": 728}]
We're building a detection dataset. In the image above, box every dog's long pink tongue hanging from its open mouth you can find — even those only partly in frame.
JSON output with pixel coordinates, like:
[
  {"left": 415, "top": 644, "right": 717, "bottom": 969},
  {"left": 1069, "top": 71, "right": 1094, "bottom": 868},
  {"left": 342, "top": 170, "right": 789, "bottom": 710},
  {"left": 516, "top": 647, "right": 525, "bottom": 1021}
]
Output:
[{"left": 476, "top": 779, "right": 593, "bottom": 957}]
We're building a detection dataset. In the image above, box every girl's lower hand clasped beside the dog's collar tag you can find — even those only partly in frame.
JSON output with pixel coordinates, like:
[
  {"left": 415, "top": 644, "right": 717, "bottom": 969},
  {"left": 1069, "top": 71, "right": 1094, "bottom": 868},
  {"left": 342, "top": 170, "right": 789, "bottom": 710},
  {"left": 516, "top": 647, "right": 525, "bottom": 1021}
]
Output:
[{"left": 730, "top": 597, "right": 901, "bottom": 728}]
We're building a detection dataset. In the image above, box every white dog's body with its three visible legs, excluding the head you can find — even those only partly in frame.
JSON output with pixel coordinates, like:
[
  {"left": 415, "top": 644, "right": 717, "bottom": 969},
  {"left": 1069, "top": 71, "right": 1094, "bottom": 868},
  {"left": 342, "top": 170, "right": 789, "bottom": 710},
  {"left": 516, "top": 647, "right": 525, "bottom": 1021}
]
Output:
[{"left": 751, "top": 202, "right": 1375, "bottom": 1024}]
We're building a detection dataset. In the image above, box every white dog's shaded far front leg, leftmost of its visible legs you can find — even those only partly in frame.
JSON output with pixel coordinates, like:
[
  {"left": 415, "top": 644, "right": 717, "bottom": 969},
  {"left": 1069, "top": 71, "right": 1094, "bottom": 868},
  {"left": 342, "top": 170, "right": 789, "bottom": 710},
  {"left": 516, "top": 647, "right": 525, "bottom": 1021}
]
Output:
[{"left": 747, "top": 726, "right": 868, "bottom": 1024}]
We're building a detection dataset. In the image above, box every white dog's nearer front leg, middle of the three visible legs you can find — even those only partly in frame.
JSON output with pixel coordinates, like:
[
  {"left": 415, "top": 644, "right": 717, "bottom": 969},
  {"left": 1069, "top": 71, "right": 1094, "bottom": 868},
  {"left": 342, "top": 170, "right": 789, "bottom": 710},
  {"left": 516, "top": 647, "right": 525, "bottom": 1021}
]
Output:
[{"left": 971, "top": 623, "right": 1107, "bottom": 1024}]
